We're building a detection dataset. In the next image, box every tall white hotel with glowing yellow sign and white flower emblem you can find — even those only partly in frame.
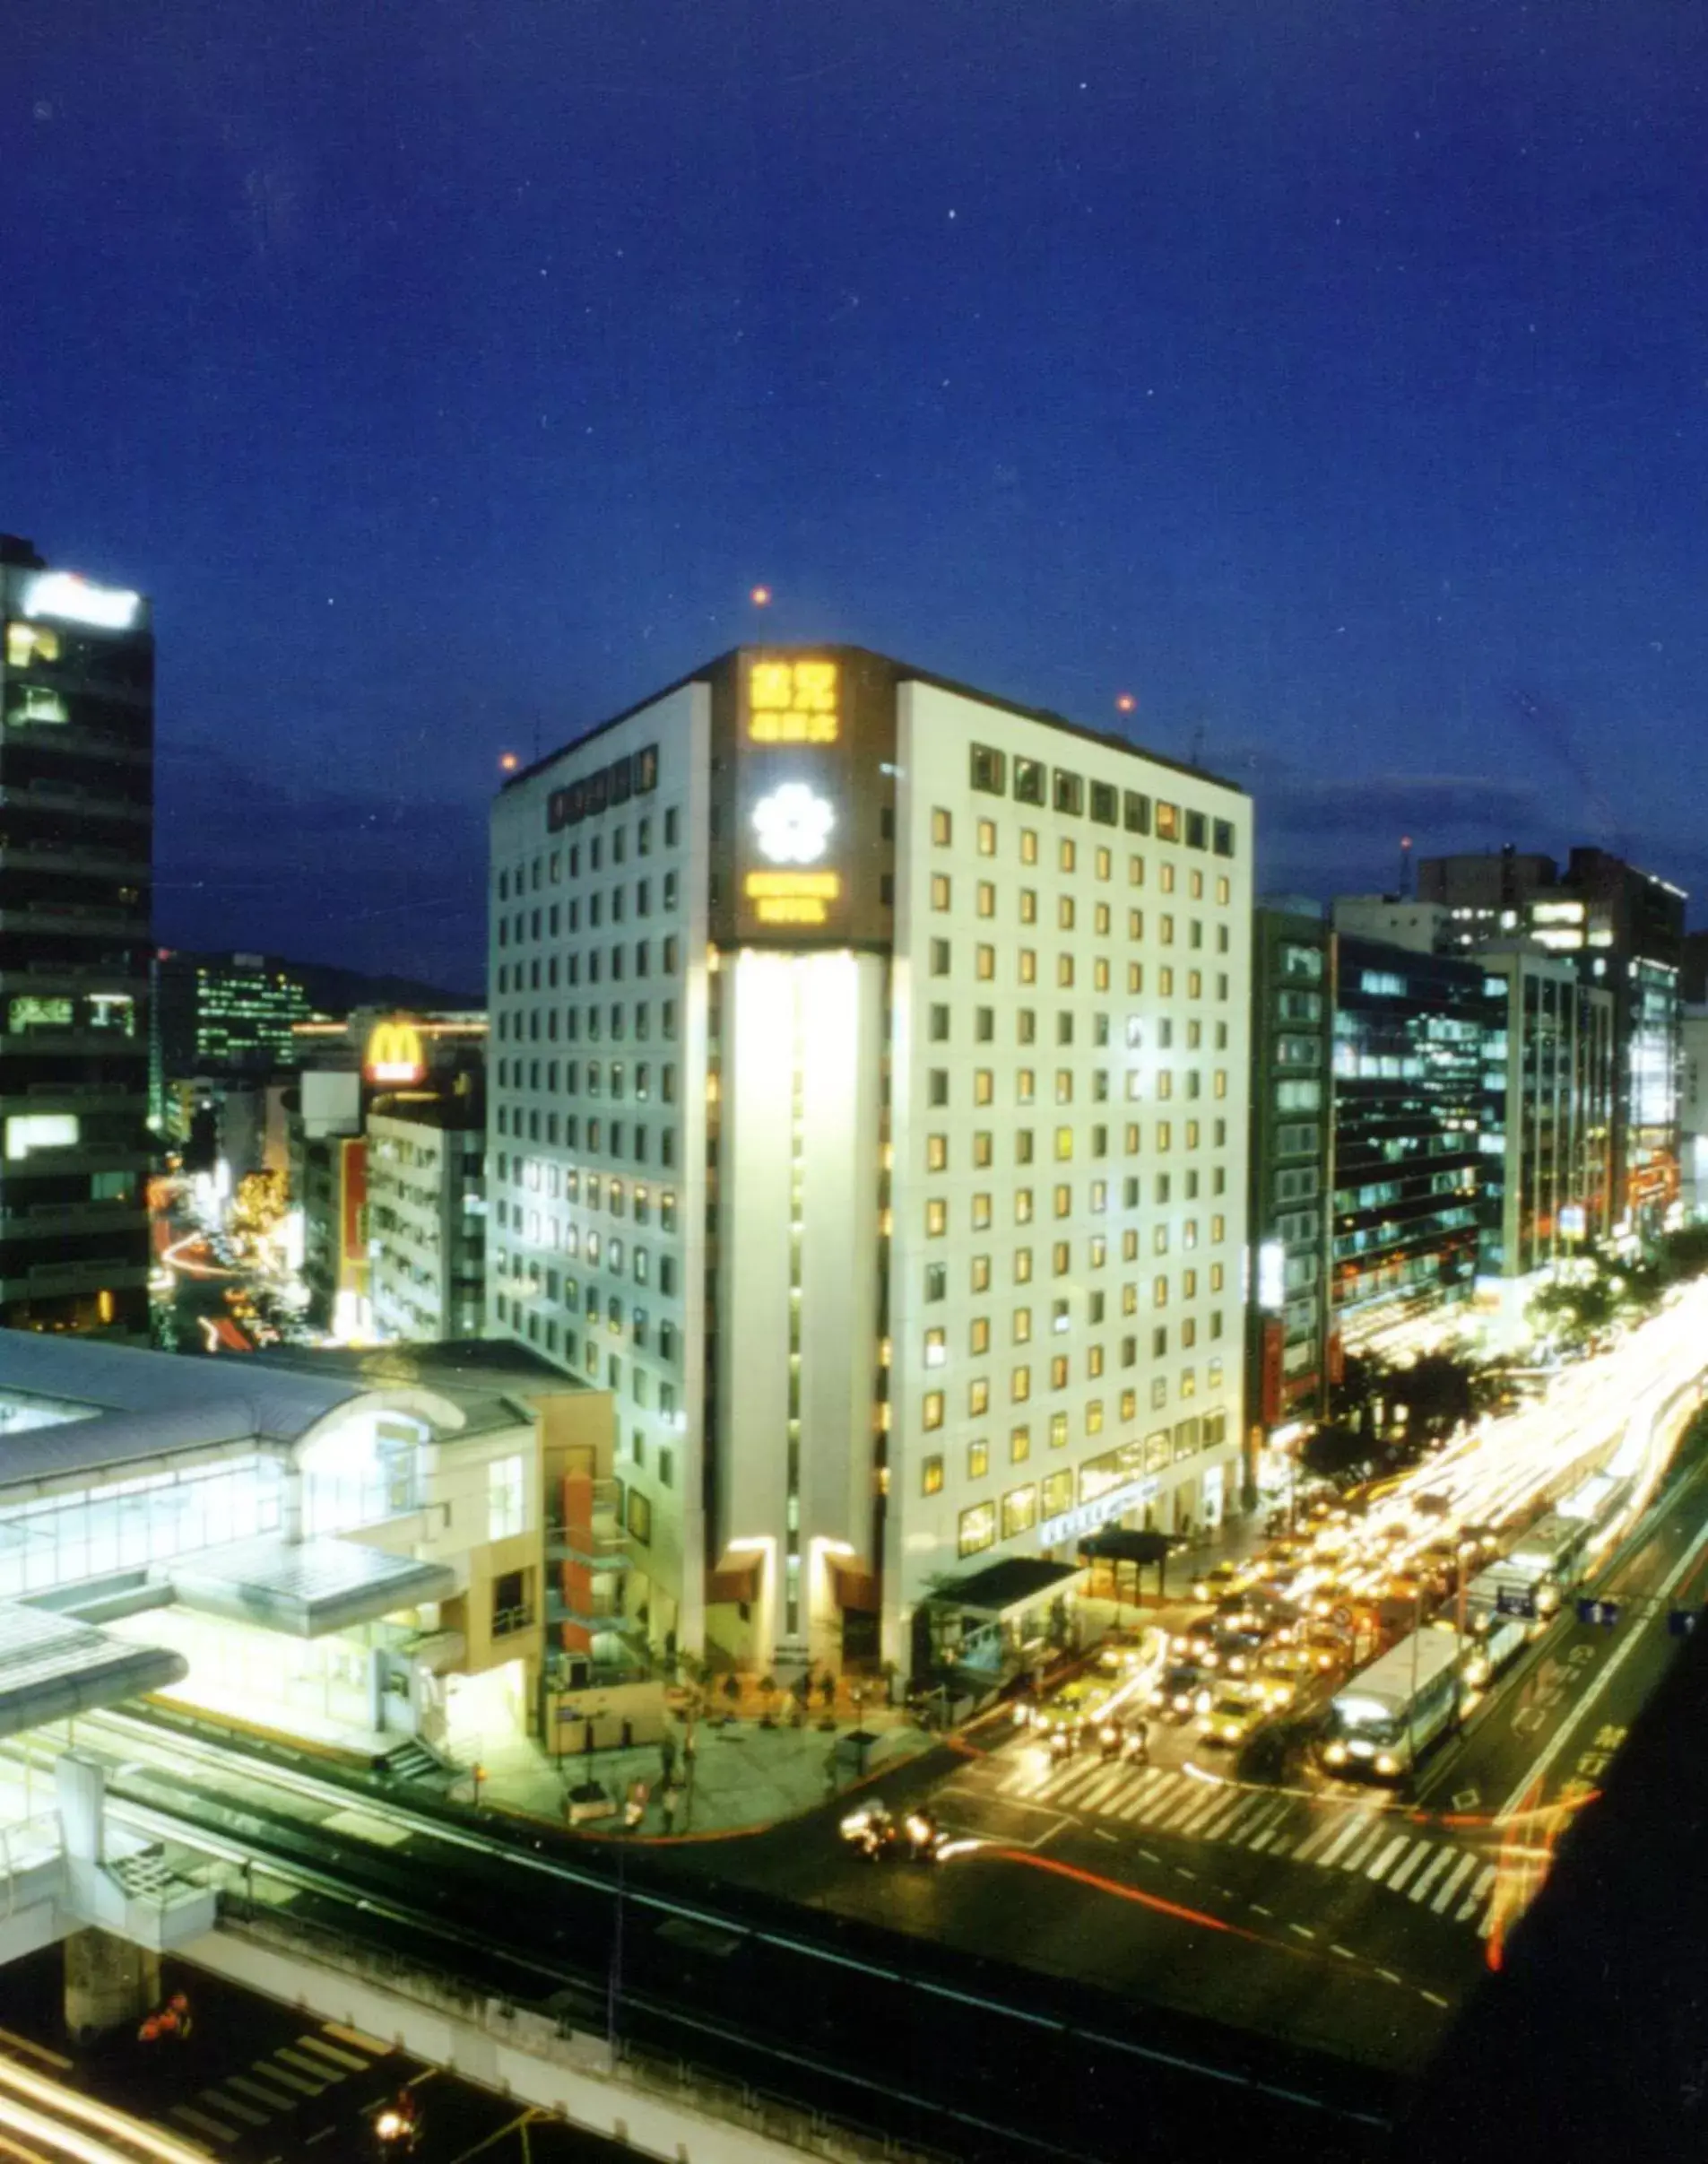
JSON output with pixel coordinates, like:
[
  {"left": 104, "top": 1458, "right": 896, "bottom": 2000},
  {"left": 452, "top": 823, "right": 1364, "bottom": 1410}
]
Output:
[{"left": 487, "top": 647, "right": 1252, "bottom": 1671}]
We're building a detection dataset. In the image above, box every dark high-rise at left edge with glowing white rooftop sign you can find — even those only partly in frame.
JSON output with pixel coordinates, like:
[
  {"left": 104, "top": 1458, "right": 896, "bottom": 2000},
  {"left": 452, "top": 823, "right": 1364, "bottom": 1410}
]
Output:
[{"left": 0, "top": 536, "right": 153, "bottom": 1337}]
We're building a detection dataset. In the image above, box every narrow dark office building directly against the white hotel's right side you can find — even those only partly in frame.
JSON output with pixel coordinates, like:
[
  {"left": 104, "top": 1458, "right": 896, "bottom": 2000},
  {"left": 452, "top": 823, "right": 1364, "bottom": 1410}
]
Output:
[{"left": 1244, "top": 896, "right": 1333, "bottom": 1489}]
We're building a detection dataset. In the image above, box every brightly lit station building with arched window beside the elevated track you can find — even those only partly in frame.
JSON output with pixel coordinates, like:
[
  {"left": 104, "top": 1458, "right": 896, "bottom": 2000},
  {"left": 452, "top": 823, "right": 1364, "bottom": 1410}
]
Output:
[{"left": 0, "top": 1331, "right": 611, "bottom": 1764}]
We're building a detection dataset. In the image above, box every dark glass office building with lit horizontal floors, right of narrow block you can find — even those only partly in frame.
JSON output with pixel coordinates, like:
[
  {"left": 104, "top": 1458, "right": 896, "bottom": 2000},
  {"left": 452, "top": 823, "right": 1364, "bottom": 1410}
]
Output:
[{"left": 1331, "top": 933, "right": 1504, "bottom": 1348}]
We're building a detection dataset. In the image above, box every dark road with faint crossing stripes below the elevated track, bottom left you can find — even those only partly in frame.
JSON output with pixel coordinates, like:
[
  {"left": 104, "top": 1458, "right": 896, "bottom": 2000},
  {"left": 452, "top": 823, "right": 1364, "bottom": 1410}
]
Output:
[{"left": 0, "top": 1948, "right": 630, "bottom": 2164}]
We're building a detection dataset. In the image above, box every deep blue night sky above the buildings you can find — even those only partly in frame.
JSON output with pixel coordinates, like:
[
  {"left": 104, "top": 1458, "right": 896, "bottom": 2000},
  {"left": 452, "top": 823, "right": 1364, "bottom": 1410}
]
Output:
[{"left": 0, "top": 0, "right": 1708, "bottom": 985}]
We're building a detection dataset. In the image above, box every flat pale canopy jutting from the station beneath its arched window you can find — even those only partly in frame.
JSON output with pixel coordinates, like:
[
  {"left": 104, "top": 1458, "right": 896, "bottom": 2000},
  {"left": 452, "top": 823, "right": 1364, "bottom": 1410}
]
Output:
[{"left": 171, "top": 1539, "right": 456, "bottom": 1638}]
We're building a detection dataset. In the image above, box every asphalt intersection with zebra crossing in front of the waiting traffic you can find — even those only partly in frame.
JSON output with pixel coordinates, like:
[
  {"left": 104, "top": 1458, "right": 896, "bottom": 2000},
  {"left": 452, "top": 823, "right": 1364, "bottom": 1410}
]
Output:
[{"left": 682, "top": 1419, "right": 1708, "bottom": 2075}]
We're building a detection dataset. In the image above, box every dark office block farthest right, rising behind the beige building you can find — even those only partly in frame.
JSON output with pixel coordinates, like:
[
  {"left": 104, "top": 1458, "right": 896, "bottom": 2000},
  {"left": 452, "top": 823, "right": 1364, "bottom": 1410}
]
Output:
[{"left": 1418, "top": 848, "right": 1686, "bottom": 1233}]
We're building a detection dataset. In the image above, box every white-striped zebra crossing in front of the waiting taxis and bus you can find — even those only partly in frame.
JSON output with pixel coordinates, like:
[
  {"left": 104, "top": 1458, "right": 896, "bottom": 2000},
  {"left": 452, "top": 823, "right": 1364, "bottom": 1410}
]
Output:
[{"left": 978, "top": 1751, "right": 1496, "bottom": 1924}]
